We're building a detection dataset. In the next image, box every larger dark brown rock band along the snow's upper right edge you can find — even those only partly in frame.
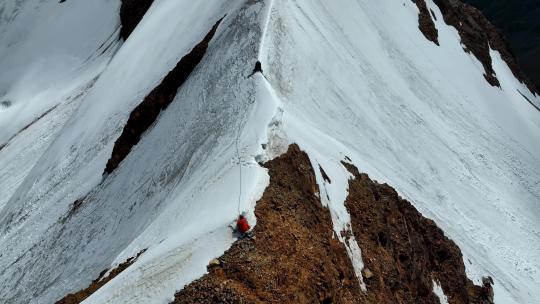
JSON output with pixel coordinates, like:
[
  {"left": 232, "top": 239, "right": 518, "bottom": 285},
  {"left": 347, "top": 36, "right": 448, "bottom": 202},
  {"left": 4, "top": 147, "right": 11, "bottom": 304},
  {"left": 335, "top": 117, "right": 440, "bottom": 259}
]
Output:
[{"left": 434, "top": 0, "right": 536, "bottom": 93}]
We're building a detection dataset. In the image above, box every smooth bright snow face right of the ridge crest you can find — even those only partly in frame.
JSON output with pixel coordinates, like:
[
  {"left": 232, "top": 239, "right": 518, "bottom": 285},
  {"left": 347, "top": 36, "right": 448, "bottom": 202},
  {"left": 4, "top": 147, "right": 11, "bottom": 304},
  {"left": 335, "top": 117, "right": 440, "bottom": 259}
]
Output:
[{"left": 261, "top": 0, "right": 540, "bottom": 303}]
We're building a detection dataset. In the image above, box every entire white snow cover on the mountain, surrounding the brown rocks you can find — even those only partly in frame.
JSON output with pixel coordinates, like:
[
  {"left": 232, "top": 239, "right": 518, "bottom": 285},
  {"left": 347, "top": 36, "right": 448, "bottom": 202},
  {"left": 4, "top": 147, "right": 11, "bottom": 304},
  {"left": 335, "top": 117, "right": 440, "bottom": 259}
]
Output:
[{"left": 0, "top": 0, "right": 540, "bottom": 304}]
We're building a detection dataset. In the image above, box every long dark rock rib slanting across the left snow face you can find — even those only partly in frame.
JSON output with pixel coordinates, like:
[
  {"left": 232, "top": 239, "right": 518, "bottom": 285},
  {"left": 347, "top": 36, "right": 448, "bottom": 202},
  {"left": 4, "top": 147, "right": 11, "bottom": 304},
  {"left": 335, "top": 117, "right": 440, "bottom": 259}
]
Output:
[{"left": 103, "top": 20, "right": 221, "bottom": 174}]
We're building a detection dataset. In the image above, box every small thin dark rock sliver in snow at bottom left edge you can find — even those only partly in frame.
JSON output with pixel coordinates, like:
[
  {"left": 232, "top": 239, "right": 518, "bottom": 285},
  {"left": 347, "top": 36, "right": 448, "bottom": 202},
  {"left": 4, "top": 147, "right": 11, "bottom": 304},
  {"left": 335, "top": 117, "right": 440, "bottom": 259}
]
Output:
[{"left": 56, "top": 249, "right": 146, "bottom": 304}]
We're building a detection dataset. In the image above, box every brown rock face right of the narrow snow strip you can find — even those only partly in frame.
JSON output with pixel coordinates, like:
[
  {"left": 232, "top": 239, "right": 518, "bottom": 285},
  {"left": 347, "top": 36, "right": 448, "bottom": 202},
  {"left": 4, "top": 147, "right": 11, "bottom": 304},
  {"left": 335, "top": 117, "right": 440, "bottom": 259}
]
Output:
[{"left": 343, "top": 163, "right": 491, "bottom": 304}]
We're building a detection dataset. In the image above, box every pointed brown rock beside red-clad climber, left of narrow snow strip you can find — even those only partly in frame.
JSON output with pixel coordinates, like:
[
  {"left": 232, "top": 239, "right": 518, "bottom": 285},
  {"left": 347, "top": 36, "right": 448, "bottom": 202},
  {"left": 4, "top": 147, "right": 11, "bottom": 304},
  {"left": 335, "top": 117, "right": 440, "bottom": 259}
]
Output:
[{"left": 174, "top": 145, "right": 362, "bottom": 303}]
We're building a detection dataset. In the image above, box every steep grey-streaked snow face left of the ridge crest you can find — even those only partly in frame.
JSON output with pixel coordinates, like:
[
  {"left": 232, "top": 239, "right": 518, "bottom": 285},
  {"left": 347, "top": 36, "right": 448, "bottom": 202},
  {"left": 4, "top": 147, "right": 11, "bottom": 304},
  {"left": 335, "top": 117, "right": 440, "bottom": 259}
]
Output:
[{"left": 0, "top": 0, "right": 276, "bottom": 303}]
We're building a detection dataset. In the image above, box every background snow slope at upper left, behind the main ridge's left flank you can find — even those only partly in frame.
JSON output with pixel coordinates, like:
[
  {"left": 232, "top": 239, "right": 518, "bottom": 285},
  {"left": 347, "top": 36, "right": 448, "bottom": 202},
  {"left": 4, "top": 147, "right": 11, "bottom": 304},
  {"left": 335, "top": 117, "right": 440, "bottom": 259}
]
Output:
[{"left": 0, "top": 0, "right": 120, "bottom": 210}]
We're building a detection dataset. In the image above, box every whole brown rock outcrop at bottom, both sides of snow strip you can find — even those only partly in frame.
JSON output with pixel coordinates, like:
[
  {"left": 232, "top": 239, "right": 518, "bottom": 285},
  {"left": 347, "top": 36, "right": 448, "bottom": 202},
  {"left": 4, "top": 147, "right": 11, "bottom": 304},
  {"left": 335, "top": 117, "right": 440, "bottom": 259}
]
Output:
[{"left": 173, "top": 145, "right": 491, "bottom": 304}]
